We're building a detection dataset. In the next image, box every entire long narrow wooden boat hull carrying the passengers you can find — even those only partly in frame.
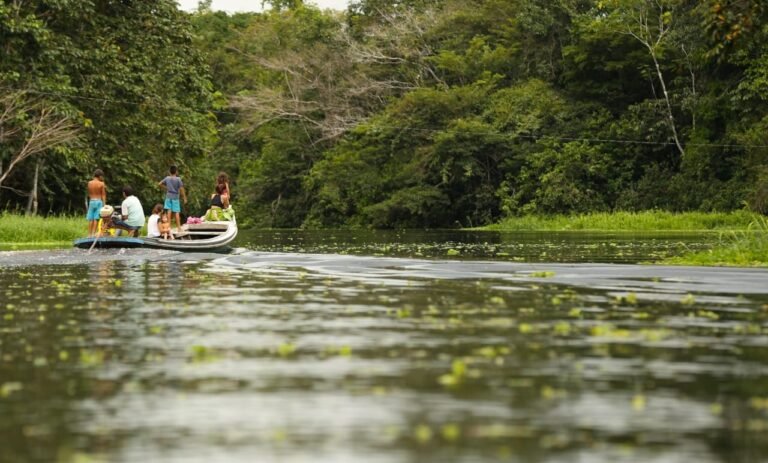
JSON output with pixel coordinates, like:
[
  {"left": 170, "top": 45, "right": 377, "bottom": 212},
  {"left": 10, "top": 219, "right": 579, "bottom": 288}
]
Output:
[{"left": 74, "top": 219, "right": 237, "bottom": 251}]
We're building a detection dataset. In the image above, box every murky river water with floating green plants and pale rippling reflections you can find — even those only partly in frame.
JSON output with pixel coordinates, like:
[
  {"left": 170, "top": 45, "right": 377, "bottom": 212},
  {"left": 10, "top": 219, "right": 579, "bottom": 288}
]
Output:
[{"left": 0, "top": 232, "right": 768, "bottom": 463}]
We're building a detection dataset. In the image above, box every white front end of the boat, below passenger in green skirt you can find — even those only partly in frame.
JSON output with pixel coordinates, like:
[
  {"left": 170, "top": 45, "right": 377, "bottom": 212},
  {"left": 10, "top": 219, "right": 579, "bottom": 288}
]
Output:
[{"left": 142, "top": 219, "right": 237, "bottom": 251}]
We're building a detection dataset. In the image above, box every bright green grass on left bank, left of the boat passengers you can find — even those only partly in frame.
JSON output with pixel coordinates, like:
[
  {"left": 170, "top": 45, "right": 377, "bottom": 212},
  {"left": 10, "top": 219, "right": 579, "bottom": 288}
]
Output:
[{"left": 0, "top": 213, "right": 88, "bottom": 244}]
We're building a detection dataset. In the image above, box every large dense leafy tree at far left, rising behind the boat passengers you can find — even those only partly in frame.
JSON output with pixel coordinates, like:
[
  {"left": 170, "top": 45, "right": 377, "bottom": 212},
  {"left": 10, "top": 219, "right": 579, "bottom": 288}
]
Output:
[{"left": 0, "top": 0, "right": 215, "bottom": 214}]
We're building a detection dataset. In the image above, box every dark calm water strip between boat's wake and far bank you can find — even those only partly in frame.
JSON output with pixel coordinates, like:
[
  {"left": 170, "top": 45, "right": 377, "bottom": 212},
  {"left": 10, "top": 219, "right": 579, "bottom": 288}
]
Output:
[{"left": 237, "top": 230, "right": 719, "bottom": 263}]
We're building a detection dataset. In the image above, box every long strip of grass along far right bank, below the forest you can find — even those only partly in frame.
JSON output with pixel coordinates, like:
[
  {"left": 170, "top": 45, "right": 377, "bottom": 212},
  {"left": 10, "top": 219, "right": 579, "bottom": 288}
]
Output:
[{"left": 483, "top": 211, "right": 759, "bottom": 231}]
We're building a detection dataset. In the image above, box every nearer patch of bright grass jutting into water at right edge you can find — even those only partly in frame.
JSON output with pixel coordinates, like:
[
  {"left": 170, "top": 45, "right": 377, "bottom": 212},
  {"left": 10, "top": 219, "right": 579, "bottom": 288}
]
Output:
[{"left": 663, "top": 217, "right": 768, "bottom": 267}]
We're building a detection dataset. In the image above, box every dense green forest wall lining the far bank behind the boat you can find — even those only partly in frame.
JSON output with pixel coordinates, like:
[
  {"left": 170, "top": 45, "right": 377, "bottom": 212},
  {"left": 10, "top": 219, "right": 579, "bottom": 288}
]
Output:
[{"left": 0, "top": 0, "right": 768, "bottom": 228}]
